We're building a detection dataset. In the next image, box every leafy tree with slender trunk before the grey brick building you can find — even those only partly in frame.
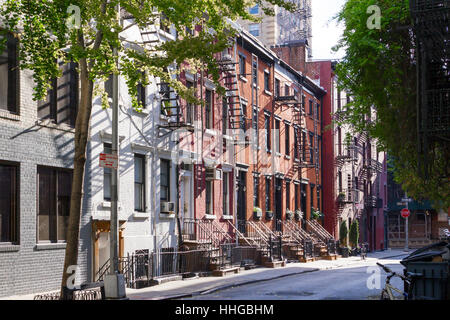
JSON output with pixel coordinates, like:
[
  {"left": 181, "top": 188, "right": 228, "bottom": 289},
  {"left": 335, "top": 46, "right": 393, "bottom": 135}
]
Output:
[{"left": 0, "top": 0, "right": 295, "bottom": 296}]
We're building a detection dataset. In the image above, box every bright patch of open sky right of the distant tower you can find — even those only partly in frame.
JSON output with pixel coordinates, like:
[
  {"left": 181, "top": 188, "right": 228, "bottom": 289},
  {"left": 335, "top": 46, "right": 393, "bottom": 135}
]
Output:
[{"left": 312, "top": 0, "right": 346, "bottom": 60}]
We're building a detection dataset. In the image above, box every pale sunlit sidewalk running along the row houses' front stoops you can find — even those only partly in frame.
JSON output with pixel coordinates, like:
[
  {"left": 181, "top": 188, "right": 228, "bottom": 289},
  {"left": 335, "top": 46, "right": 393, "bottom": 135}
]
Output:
[{"left": 0, "top": 249, "right": 412, "bottom": 300}]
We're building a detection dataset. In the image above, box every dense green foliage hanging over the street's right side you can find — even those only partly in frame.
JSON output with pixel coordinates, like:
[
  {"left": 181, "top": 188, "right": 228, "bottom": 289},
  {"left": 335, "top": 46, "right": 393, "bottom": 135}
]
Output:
[{"left": 334, "top": 0, "right": 450, "bottom": 208}]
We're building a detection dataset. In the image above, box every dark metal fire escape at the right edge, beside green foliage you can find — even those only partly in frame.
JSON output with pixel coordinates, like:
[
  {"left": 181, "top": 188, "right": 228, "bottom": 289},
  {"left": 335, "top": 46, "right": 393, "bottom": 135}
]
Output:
[{"left": 410, "top": 0, "right": 450, "bottom": 181}]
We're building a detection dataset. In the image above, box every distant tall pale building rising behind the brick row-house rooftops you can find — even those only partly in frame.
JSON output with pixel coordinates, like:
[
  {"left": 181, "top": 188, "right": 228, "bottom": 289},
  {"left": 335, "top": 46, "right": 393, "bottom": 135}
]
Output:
[{"left": 238, "top": 0, "right": 312, "bottom": 58}]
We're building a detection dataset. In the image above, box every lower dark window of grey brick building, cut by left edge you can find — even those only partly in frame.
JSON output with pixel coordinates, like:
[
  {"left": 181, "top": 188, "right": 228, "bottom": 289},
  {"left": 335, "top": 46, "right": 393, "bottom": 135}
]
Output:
[{"left": 0, "top": 163, "right": 19, "bottom": 243}]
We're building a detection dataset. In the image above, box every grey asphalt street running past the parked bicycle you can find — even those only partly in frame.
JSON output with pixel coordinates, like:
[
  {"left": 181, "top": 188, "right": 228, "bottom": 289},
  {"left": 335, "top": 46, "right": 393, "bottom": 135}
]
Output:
[{"left": 181, "top": 257, "right": 403, "bottom": 300}]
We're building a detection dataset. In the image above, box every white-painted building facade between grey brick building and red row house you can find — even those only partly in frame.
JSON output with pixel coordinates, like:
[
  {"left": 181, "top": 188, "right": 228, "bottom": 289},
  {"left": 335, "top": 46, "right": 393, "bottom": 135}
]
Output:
[{"left": 83, "top": 14, "right": 181, "bottom": 281}]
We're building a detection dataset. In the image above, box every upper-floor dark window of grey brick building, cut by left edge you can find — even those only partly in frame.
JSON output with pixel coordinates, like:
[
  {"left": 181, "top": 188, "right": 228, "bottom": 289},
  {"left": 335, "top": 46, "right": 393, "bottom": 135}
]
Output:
[{"left": 0, "top": 33, "right": 19, "bottom": 113}]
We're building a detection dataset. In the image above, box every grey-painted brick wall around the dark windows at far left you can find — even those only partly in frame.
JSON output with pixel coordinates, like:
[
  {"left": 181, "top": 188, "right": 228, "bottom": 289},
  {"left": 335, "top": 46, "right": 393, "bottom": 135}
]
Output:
[{"left": 0, "top": 71, "right": 77, "bottom": 296}]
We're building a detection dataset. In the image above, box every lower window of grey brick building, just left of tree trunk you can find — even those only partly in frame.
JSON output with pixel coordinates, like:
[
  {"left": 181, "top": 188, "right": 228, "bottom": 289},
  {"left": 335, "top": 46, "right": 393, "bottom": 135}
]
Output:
[{"left": 37, "top": 166, "right": 72, "bottom": 242}]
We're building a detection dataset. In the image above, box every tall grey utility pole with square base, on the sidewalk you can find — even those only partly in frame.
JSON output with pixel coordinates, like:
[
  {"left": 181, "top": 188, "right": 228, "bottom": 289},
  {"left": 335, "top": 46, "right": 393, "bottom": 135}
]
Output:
[{"left": 105, "top": 5, "right": 126, "bottom": 299}]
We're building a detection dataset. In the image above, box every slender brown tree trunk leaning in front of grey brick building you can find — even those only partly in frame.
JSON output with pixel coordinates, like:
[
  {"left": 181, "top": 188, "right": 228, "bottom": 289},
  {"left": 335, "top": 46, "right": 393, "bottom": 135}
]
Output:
[{"left": 61, "top": 55, "right": 94, "bottom": 300}]
